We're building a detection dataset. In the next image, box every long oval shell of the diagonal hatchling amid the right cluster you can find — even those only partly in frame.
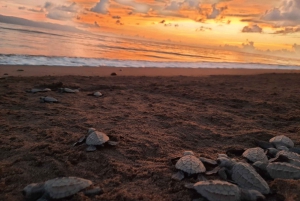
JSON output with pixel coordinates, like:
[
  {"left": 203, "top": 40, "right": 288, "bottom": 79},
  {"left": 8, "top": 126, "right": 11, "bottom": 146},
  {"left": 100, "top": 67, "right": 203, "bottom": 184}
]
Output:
[{"left": 231, "top": 162, "right": 270, "bottom": 194}]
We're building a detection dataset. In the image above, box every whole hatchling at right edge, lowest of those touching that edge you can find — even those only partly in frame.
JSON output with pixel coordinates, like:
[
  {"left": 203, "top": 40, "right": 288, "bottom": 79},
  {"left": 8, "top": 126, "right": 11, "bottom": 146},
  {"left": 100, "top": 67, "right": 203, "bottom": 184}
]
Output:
[{"left": 253, "top": 161, "right": 300, "bottom": 179}]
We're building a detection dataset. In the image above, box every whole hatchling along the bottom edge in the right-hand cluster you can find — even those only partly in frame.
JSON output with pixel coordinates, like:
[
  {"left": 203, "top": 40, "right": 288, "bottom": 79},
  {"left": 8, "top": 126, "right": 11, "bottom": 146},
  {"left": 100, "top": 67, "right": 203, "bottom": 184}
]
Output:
[{"left": 186, "top": 180, "right": 265, "bottom": 201}]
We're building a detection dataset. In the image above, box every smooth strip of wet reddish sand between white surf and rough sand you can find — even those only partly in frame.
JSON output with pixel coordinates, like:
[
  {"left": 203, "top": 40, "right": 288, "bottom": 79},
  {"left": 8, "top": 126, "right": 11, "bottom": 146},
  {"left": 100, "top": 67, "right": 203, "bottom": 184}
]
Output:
[{"left": 0, "top": 65, "right": 300, "bottom": 77}]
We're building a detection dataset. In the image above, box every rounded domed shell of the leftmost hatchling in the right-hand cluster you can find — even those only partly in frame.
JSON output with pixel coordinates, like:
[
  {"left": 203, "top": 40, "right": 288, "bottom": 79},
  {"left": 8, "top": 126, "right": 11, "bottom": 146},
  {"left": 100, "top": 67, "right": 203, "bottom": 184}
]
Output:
[{"left": 175, "top": 155, "right": 206, "bottom": 174}]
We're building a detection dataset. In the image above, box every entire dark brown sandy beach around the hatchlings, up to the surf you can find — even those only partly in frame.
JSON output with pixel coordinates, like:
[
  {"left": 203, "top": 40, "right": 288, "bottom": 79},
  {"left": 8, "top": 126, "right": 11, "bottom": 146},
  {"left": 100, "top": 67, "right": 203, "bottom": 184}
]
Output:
[{"left": 0, "top": 66, "right": 300, "bottom": 201}]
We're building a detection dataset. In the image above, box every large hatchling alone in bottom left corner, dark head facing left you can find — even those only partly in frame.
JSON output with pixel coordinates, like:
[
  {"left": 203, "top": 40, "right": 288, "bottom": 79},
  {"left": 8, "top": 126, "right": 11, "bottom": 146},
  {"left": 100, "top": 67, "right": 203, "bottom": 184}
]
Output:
[{"left": 22, "top": 177, "right": 92, "bottom": 201}]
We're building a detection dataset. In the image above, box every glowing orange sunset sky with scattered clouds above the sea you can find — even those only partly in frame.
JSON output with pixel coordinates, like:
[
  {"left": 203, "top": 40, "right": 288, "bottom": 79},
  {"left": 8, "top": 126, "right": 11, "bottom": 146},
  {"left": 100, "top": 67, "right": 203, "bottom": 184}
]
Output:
[{"left": 0, "top": 0, "right": 300, "bottom": 54}]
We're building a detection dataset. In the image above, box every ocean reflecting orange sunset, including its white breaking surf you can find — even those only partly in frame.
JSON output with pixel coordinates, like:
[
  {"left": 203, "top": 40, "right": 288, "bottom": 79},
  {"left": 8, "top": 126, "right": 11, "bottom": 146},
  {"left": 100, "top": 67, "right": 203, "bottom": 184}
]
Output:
[{"left": 0, "top": 23, "right": 300, "bottom": 69}]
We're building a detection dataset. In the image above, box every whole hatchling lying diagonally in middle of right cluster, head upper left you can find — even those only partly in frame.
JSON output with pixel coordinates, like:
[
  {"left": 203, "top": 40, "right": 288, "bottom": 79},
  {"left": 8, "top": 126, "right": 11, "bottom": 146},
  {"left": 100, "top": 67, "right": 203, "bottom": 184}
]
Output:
[{"left": 217, "top": 157, "right": 270, "bottom": 194}]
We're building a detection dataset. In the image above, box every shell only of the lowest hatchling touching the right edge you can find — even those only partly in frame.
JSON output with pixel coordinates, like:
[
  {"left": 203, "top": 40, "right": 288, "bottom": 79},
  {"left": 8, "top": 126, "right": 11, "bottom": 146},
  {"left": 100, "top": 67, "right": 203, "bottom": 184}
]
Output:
[{"left": 267, "top": 162, "right": 300, "bottom": 179}]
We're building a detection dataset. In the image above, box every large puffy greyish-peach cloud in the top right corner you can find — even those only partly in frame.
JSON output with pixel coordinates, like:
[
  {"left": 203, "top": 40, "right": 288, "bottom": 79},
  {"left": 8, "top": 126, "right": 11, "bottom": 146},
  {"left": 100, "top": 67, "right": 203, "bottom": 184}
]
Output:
[{"left": 262, "top": 0, "right": 300, "bottom": 25}]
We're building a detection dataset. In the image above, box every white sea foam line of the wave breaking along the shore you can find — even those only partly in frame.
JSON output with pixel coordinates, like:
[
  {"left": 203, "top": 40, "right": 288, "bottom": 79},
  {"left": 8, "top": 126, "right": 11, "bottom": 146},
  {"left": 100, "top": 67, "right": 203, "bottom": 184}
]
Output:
[{"left": 0, "top": 54, "right": 300, "bottom": 70}]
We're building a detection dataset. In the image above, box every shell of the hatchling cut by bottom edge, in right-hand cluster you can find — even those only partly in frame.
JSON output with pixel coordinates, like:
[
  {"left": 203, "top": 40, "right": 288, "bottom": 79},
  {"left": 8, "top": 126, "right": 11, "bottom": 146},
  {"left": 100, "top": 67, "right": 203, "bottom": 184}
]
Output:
[{"left": 194, "top": 180, "right": 241, "bottom": 201}]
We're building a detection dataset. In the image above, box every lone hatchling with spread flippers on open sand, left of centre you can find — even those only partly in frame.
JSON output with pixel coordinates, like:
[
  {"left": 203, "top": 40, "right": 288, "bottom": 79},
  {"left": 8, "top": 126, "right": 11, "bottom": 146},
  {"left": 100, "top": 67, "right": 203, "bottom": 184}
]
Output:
[{"left": 74, "top": 128, "right": 118, "bottom": 151}]
